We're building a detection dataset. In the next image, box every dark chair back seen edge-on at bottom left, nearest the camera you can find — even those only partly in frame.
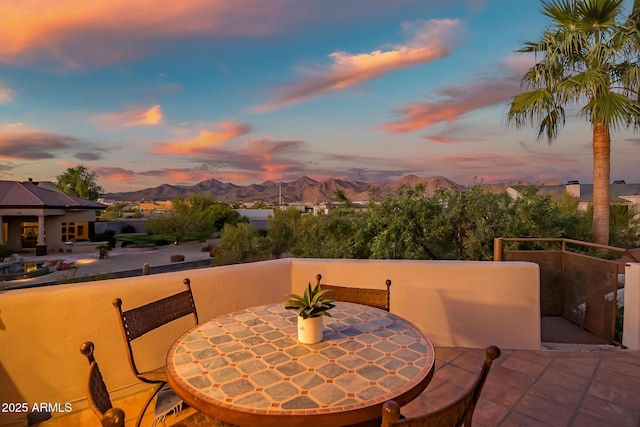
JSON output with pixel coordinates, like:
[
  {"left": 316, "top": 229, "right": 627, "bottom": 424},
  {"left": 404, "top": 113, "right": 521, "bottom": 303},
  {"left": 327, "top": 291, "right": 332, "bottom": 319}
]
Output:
[{"left": 80, "top": 341, "right": 125, "bottom": 427}]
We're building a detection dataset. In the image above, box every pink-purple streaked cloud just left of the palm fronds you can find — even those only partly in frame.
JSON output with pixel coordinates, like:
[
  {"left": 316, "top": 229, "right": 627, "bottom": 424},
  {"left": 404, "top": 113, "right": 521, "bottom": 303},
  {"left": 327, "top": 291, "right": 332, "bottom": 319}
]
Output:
[{"left": 379, "top": 58, "right": 530, "bottom": 133}]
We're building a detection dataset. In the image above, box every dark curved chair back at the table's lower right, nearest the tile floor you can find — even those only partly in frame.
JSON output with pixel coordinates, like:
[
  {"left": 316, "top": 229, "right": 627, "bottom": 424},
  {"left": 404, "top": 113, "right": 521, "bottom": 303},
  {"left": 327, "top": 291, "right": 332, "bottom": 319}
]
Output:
[{"left": 382, "top": 345, "right": 500, "bottom": 427}]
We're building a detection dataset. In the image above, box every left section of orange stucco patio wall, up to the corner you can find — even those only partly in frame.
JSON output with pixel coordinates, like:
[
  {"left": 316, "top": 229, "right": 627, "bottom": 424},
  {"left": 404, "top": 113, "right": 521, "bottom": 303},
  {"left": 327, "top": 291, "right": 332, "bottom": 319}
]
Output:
[{"left": 0, "top": 260, "right": 291, "bottom": 426}]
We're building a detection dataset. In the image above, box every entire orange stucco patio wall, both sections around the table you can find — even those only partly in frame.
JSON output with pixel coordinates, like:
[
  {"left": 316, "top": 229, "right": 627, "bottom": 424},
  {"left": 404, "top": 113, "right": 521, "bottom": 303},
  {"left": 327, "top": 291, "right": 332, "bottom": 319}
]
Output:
[{"left": 0, "top": 259, "right": 540, "bottom": 425}]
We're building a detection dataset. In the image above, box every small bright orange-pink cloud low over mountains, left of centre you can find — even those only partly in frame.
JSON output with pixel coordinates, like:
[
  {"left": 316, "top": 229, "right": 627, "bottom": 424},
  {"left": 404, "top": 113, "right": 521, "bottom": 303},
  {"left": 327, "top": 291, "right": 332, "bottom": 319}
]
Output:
[{"left": 153, "top": 120, "right": 251, "bottom": 155}]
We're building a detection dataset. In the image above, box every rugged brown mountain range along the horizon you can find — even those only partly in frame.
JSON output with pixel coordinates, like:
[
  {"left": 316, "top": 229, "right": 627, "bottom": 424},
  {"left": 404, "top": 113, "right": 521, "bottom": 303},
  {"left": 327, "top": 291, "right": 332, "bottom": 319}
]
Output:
[{"left": 103, "top": 175, "right": 559, "bottom": 204}]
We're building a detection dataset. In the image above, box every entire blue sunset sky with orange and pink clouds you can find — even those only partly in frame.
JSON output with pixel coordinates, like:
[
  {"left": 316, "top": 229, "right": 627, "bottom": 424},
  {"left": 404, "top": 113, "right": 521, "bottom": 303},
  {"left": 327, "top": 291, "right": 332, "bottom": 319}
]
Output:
[{"left": 0, "top": 0, "right": 640, "bottom": 192}]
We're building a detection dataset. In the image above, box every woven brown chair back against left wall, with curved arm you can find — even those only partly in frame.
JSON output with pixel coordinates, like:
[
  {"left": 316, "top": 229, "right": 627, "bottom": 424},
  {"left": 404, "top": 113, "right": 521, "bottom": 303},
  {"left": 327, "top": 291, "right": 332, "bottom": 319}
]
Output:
[{"left": 113, "top": 278, "right": 198, "bottom": 382}]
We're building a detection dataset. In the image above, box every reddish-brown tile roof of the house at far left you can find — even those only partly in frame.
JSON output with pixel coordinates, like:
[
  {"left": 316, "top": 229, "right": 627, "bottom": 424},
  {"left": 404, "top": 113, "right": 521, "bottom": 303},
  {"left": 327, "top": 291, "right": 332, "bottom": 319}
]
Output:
[{"left": 0, "top": 181, "right": 106, "bottom": 209}]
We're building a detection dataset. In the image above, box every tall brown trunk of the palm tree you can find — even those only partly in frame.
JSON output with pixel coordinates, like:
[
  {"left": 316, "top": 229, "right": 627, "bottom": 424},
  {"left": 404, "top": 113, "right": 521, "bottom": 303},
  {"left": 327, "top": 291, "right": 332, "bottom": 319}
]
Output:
[{"left": 591, "top": 123, "right": 611, "bottom": 245}]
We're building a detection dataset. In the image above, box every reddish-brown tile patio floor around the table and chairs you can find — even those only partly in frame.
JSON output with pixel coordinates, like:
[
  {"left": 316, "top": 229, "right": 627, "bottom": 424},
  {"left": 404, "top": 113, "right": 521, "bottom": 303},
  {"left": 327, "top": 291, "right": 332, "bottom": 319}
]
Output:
[{"left": 167, "top": 347, "right": 640, "bottom": 427}]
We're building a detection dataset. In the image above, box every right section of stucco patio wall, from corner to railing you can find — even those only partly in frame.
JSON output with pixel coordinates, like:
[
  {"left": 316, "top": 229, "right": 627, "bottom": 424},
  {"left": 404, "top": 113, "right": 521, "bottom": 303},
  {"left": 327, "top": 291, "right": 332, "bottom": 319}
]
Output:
[{"left": 292, "top": 259, "right": 540, "bottom": 350}]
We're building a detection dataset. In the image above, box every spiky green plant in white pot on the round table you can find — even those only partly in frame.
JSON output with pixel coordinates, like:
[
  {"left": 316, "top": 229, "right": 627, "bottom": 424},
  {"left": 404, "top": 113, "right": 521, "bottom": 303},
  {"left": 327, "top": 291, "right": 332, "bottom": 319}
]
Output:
[{"left": 284, "top": 283, "right": 335, "bottom": 344}]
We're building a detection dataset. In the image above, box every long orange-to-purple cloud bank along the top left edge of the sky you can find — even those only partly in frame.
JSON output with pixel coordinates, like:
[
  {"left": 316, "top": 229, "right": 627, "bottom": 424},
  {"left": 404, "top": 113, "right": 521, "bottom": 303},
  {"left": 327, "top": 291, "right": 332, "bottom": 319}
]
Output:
[{"left": 0, "top": 0, "right": 439, "bottom": 69}]
